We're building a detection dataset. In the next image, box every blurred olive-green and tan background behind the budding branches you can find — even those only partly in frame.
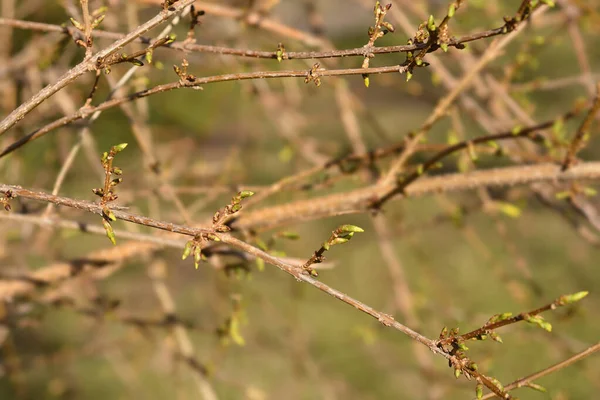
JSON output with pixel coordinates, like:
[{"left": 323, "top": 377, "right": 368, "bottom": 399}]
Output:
[{"left": 0, "top": 0, "right": 600, "bottom": 400}]
